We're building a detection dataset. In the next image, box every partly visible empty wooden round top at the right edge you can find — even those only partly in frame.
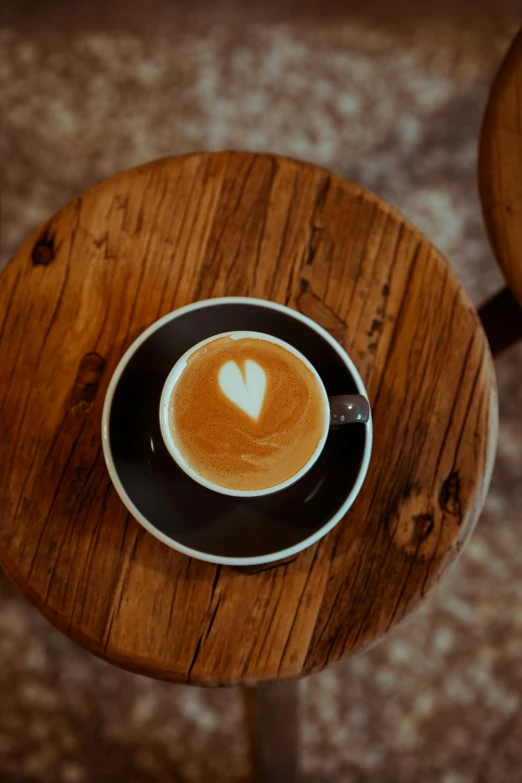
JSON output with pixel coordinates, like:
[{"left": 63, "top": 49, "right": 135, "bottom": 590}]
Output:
[{"left": 479, "top": 29, "right": 522, "bottom": 305}]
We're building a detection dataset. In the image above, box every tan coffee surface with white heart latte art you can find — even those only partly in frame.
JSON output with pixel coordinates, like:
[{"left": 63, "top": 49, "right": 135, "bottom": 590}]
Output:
[{"left": 169, "top": 337, "right": 325, "bottom": 490}]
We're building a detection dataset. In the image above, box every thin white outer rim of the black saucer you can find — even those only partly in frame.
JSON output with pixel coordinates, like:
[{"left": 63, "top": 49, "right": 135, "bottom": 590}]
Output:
[{"left": 102, "top": 296, "right": 373, "bottom": 566}]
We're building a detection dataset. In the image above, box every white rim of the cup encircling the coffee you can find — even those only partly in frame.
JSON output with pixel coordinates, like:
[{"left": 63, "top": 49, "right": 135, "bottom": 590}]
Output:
[{"left": 159, "top": 329, "right": 330, "bottom": 498}]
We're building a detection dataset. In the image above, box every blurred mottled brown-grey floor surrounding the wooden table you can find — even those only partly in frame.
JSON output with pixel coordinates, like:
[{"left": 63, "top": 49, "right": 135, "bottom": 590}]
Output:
[{"left": 0, "top": 0, "right": 522, "bottom": 783}]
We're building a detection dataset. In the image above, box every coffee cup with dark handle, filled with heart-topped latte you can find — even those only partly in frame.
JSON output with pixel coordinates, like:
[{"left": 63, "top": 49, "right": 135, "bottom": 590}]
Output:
[{"left": 159, "top": 331, "right": 370, "bottom": 497}]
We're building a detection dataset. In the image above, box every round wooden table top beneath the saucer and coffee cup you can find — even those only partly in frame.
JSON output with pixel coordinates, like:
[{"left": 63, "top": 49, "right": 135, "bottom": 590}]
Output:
[{"left": 0, "top": 153, "right": 497, "bottom": 685}]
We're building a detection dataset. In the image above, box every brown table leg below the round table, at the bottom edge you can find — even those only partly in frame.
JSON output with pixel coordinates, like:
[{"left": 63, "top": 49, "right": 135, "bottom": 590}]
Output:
[{"left": 244, "top": 680, "right": 299, "bottom": 783}]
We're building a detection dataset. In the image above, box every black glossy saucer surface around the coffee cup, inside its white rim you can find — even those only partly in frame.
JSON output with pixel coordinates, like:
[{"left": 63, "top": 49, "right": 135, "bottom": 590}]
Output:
[{"left": 106, "top": 300, "right": 368, "bottom": 564}]
